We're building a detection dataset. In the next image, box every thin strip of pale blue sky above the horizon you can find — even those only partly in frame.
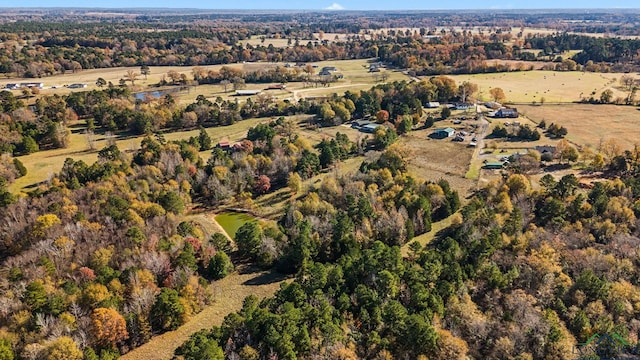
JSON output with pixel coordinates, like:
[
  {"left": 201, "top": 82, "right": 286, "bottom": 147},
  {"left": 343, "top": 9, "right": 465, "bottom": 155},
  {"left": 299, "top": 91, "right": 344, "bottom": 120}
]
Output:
[{"left": 5, "top": 0, "right": 640, "bottom": 10}]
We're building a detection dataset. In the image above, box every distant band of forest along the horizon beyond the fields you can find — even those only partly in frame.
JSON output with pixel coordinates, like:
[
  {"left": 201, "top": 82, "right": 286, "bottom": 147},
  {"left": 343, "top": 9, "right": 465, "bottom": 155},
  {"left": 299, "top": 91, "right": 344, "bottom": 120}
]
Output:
[{"left": 0, "top": 13, "right": 638, "bottom": 78}]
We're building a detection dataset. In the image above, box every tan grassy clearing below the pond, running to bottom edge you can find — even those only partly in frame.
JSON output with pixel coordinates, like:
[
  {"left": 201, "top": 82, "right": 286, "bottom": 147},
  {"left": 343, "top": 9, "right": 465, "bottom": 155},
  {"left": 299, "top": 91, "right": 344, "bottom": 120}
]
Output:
[{"left": 120, "top": 271, "right": 284, "bottom": 360}]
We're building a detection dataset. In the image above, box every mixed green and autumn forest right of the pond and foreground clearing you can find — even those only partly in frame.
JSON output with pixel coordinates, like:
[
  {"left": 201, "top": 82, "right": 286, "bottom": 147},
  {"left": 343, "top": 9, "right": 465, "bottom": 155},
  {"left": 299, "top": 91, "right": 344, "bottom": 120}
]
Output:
[{"left": 176, "top": 142, "right": 640, "bottom": 359}]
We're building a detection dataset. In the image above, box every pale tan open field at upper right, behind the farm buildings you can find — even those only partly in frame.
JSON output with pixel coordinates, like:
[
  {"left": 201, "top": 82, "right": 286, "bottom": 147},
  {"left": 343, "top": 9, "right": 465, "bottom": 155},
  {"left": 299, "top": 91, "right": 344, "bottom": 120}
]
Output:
[{"left": 450, "top": 70, "right": 637, "bottom": 103}]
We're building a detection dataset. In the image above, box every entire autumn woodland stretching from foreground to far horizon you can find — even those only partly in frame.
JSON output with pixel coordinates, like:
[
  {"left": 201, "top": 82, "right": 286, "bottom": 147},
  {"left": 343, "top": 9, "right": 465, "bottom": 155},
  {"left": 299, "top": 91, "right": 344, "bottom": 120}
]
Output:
[{"left": 0, "top": 9, "right": 640, "bottom": 360}]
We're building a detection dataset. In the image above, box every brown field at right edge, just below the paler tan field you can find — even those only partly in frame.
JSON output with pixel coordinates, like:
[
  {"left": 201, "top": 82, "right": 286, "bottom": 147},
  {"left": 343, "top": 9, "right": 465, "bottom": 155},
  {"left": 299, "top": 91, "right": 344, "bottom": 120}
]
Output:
[{"left": 518, "top": 104, "right": 640, "bottom": 149}]
